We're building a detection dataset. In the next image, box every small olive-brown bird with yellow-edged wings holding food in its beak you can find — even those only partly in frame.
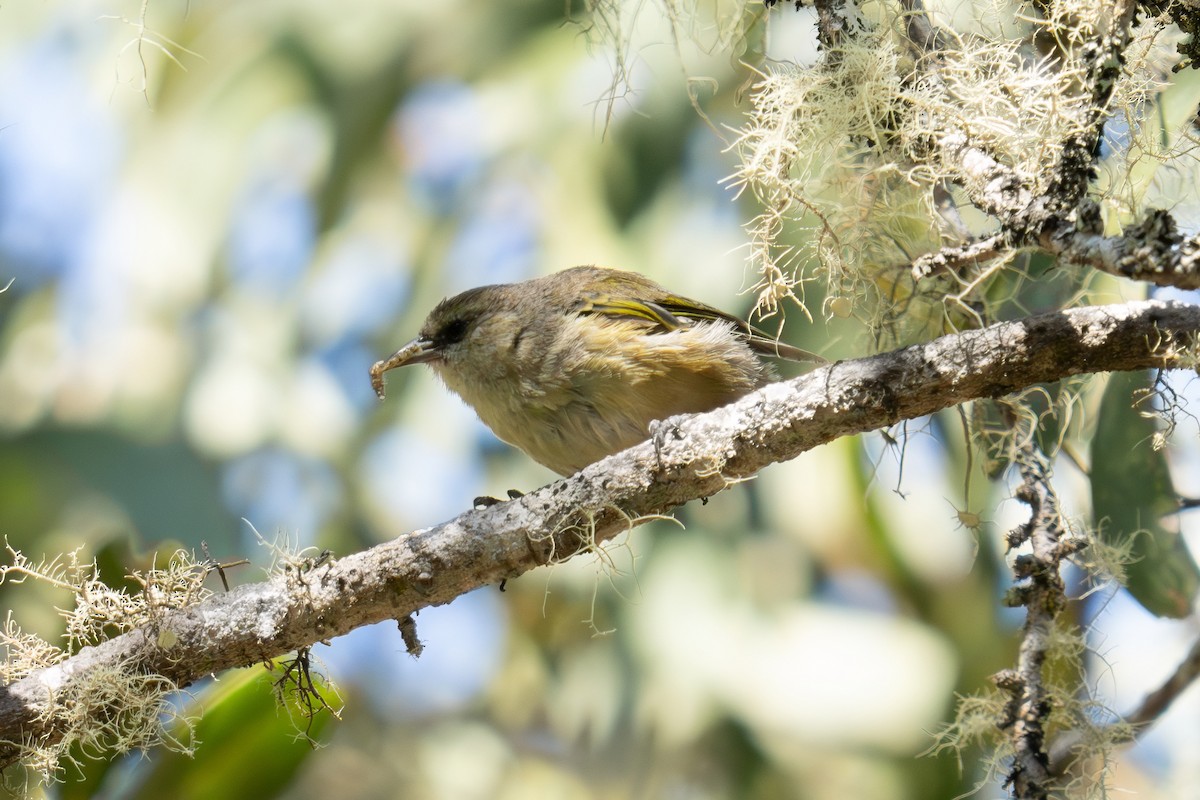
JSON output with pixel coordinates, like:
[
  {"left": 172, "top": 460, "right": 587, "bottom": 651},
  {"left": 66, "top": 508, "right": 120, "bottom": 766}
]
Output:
[{"left": 371, "top": 266, "right": 823, "bottom": 475}]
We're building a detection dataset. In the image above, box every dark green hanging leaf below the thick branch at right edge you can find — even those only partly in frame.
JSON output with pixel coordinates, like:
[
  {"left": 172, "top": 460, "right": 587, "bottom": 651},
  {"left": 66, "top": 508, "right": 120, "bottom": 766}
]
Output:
[{"left": 1092, "top": 373, "right": 1200, "bottom": 618}]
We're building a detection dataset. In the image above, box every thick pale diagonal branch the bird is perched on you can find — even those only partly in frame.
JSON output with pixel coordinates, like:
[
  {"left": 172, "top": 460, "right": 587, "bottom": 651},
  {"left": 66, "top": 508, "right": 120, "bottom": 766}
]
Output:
[{"left": 0, "top": 301, "right": 1200, "bottom": 765}]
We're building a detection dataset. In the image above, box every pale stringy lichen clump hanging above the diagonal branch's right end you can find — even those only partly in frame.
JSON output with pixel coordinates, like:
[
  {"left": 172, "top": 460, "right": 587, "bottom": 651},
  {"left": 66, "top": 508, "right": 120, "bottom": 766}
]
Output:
[{"left": 734, "top": 0, "right": 1176, "bottom": 323}]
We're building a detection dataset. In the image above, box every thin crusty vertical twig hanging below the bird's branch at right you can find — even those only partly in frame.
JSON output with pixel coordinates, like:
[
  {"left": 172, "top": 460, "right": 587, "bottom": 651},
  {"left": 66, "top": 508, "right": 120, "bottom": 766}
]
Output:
[{"left": 994, "top": 448, "right": 1084, "bottom": 800}]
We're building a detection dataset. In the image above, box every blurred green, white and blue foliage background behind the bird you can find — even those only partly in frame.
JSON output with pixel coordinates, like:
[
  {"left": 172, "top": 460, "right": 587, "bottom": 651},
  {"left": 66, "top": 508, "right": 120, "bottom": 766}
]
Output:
[{"left": 0, "top": 0, "right": 1200, "bottom": 800}]
